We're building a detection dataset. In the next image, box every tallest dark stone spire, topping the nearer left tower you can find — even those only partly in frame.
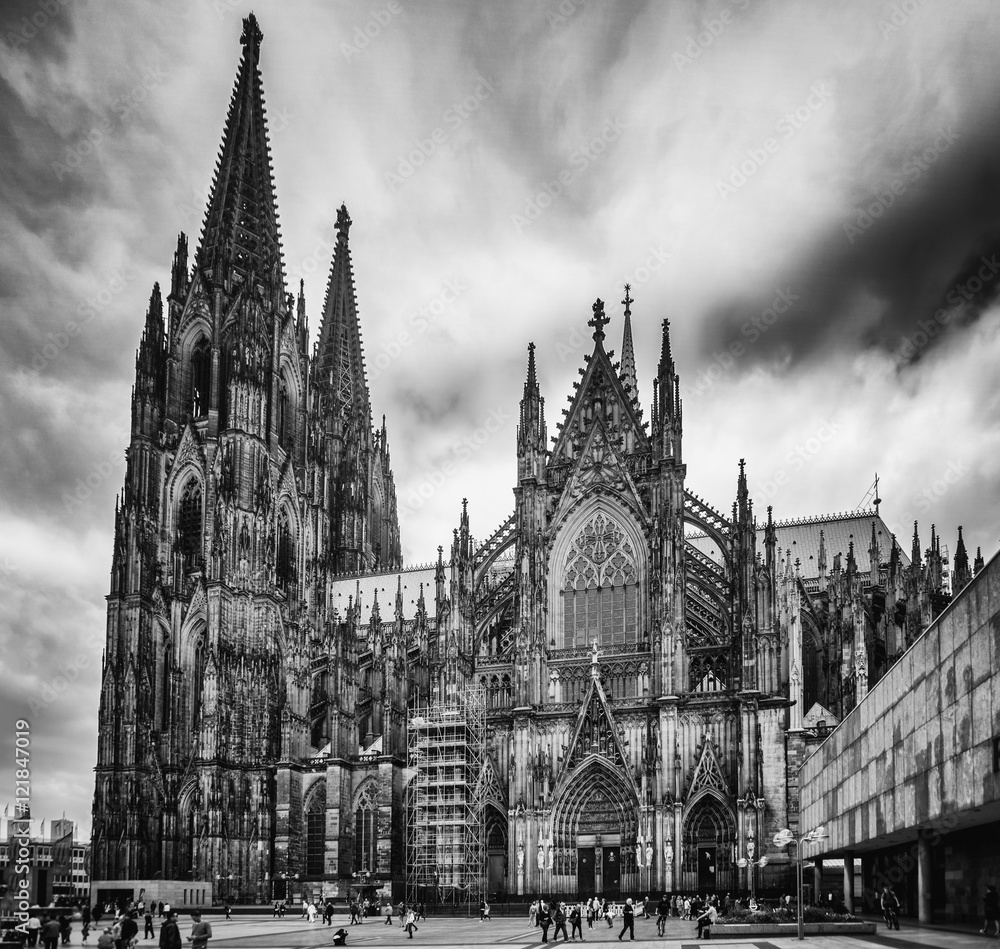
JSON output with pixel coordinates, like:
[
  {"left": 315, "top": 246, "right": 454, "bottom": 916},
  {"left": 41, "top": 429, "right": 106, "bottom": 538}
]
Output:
[{"left": 197, "top": 13, "right": 284, "bottom": 286}]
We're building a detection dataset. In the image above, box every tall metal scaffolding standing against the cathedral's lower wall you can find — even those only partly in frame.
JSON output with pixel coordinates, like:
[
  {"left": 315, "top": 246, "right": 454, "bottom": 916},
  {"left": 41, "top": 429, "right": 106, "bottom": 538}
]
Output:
[{"left": 406, "top": 689, "right": 486, "bottom": 913}]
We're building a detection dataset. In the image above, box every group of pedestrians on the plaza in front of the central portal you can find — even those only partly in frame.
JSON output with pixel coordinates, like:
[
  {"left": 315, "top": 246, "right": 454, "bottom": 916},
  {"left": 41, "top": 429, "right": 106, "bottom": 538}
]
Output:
[{"left": 528, "top": 893, "right": 728, "bottom": 942}]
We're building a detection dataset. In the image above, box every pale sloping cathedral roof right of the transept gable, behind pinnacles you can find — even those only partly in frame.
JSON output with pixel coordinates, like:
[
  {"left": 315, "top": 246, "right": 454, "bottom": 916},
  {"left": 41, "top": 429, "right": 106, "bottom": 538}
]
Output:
[{"left": 687, "top": 510, "right": 910, "bottom": 582}]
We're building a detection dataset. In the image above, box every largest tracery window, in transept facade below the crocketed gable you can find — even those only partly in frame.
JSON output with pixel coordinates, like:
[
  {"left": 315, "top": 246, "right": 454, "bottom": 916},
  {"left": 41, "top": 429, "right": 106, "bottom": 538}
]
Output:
[{"left": 562, "top": 511, "right": 639, "bottom": 648}]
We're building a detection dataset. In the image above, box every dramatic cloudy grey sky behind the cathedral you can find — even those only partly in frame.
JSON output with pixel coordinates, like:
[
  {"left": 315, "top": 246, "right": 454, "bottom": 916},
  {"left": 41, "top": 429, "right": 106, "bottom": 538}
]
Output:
[{"left": 0, "top": 0, "right": 1000, "bottom": 833}]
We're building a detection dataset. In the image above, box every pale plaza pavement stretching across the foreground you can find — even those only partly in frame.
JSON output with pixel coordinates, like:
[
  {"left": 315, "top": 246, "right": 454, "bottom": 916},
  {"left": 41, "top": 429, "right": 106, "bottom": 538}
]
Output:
[{"left": 71, "top": 913, "right": 1000, "bottom": 949}]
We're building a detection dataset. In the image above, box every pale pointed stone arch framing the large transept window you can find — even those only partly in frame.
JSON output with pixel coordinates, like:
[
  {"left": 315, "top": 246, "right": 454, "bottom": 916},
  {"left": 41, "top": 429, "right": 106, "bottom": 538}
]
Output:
[{"left": 547, "top": 496, "right": 649, "bottom": 646}]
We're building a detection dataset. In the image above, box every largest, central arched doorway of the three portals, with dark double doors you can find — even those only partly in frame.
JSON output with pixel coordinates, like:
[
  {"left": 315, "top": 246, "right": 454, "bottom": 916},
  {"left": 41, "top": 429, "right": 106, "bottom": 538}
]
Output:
[{"left": 552, "top": 755, "right": 640, "bottom": 896}]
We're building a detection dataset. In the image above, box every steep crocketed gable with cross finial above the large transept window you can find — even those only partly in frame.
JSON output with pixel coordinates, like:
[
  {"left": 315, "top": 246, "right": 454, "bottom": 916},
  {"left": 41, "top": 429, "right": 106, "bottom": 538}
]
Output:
[{"left": 550, "top": 300, "right": 648, "bottom": 464}]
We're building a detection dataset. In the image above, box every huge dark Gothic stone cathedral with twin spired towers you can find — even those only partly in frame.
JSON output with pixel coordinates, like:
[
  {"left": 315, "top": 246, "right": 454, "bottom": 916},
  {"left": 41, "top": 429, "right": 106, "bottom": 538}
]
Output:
[{"left": 92, "top": 15, "right": 982, "bottom": 902}]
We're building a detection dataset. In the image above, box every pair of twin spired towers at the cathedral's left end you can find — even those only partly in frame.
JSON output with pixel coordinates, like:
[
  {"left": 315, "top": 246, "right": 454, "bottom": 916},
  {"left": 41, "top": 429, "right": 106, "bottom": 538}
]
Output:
[{"left": 92, "top": 15, "right": 400, "bottom": 900}]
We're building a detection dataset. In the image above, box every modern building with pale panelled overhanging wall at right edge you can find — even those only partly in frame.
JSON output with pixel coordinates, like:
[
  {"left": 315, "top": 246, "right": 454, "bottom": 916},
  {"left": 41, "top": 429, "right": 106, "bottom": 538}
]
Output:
[{"left": 800, "top": 555, "right": 1000, "bottom": 918}]
